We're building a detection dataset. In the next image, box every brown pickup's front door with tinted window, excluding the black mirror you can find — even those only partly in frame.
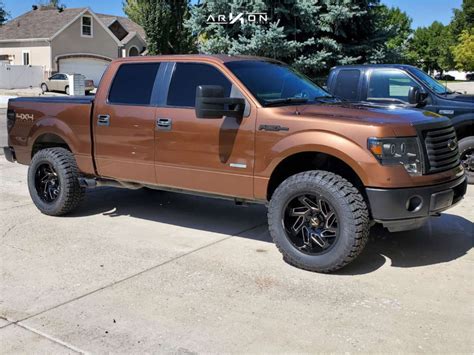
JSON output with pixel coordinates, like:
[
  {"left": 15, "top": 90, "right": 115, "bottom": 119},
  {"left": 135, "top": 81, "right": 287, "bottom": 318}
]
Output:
[{"left": 155, "top": 62, "right": 256, "bottom": 198}]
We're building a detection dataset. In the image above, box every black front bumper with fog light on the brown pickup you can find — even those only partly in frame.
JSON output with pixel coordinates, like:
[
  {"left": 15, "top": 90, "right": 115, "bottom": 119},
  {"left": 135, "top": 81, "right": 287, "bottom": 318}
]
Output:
[{"left": 366, "top": 175, "right": 467, "bottom": 232}]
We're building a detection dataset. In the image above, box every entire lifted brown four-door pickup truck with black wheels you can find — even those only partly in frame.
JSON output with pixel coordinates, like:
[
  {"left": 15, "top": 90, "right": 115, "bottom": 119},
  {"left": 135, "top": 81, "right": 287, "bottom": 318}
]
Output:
[{"left": 4, "top": 55, "right": 466, "bottom": 272}]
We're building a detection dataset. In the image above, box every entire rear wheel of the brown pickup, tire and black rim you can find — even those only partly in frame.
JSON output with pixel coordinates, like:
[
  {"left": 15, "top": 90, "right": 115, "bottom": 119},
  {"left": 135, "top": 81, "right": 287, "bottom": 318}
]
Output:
[{"left": 28, "top": 148, "right": 85, "bottom": 216}]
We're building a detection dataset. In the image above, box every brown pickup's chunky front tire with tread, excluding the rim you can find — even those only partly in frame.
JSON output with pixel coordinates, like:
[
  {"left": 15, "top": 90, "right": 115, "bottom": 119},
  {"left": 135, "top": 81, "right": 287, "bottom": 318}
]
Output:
[{"left": 268, "top": 170, "right": 370, "bottom": 273}]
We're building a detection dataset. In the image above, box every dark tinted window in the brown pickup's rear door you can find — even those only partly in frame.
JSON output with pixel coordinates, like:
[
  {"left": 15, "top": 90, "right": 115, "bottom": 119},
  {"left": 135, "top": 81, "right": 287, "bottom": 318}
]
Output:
[{"left": 109, "top": 63, "right": 160, "bottom": 105}]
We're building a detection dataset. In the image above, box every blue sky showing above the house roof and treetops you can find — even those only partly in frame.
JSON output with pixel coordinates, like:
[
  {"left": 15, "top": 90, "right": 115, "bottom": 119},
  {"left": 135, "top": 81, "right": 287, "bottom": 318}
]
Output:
[{"left": 3, "top": 0, "right": 462, "bottom": 28}]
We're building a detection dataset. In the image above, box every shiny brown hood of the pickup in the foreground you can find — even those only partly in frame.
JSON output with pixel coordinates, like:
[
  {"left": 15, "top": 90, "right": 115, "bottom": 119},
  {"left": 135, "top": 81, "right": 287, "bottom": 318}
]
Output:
[{"left": 285, "top": 102, "right": 446, "bottom": 126}]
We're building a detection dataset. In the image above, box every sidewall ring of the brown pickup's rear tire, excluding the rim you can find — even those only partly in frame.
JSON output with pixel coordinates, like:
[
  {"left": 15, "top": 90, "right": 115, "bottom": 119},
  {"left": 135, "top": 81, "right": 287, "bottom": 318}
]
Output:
[{"left": 28, "top": 150, "right": 68, "bottom": 215}]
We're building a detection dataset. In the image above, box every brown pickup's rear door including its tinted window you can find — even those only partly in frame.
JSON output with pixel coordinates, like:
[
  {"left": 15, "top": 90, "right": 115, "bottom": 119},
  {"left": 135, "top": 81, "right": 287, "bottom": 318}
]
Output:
[{"left": 92, "top": 62, "right": 160, "bottom": 184}]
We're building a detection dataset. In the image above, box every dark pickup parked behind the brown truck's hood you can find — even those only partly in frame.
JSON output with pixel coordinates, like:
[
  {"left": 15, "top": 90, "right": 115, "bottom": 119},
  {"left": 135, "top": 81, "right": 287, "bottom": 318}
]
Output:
[{"left": 327, "top": 64, "right": 474, "bottom": 184}]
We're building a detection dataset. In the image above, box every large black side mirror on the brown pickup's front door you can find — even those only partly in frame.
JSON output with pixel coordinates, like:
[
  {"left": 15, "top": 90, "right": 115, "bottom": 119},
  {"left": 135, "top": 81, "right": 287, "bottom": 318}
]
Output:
[{"left": 195, "top": 85, "right": 245, "bottom": 118}]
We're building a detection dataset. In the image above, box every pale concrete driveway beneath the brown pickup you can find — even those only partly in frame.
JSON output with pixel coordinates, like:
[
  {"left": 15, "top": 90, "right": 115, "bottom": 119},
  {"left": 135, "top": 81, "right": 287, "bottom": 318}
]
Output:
[{"left": 0, "top": 112, "right": 474, "bottom": 353}]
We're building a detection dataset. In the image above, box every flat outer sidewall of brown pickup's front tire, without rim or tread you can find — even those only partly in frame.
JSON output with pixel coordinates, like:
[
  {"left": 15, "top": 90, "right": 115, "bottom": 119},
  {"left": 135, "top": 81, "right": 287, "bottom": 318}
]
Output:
[{"left": 269, "top": 175, "right": 362, "bottom": 269}]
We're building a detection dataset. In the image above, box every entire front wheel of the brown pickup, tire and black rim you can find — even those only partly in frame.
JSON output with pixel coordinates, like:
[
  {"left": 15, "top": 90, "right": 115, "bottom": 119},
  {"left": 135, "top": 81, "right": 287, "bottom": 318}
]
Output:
[{"left": 268, "top": 170, "right": 369, "bottom": 272}]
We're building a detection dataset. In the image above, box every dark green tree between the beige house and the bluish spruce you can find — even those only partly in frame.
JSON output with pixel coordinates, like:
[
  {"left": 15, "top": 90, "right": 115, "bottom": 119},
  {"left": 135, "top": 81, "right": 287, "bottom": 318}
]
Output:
[{"left": 123, "top": 0, "right": 194, "bottom": 54}]
